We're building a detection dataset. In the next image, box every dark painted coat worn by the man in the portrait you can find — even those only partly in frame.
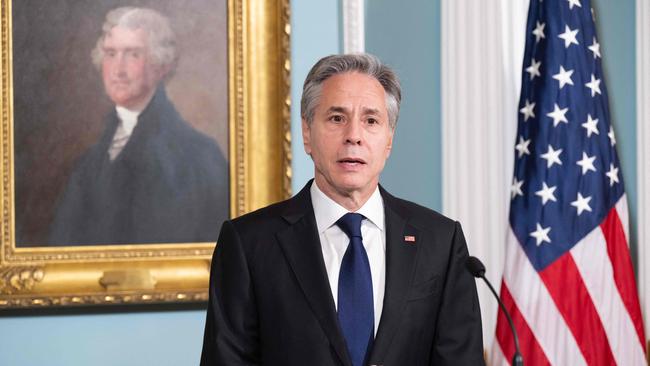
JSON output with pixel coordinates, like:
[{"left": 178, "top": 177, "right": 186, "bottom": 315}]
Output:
[{"left": 49, "top": 88, "right": 229, "bottom": 245}]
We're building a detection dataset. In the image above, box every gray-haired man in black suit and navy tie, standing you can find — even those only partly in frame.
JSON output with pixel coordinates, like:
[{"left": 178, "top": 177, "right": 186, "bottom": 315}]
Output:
[{"left": 201, "top": 55, "right": 483, "bottom": 366}]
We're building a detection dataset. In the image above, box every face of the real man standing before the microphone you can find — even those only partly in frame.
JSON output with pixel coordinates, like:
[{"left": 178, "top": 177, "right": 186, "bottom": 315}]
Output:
[{"left": 302, "top": 72, "right": 393, "bottom": 203}]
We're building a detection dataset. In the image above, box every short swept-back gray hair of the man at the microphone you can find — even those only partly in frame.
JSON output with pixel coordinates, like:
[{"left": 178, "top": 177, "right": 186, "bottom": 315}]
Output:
[{"left": 300, "top": 53, "right": 402, "bottom": 130}]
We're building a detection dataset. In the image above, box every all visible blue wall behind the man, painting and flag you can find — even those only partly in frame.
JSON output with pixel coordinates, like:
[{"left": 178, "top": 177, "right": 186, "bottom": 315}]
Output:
[{"left": 0, "top": 0, "right": 636, "bottom": 366}]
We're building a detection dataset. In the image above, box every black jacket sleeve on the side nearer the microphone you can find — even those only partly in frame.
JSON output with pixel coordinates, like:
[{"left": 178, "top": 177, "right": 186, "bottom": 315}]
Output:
[{"left": 431, "top": 223, "right": 485, "bottom": 366}]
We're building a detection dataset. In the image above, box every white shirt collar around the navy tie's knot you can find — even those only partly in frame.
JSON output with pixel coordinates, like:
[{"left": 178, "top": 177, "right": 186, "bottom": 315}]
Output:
[{"left": 309, "top": 181, "right": 384, "bottom": 233}]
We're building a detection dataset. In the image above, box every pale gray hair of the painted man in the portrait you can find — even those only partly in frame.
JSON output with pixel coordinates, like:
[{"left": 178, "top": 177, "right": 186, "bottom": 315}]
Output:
[{"left": 91, "top": 6, "right": 178, "bottom": 75}]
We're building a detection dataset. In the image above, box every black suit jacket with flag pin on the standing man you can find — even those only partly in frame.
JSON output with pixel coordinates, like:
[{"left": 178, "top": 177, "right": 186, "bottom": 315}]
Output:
[{"left": 201, "top": 184, "right": 483, "bottom": 366}]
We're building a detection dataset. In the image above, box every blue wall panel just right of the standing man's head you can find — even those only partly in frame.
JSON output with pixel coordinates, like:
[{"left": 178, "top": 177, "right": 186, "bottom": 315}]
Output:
[{"left": 366, "top": 0, "right": 442, "bottom": 211}]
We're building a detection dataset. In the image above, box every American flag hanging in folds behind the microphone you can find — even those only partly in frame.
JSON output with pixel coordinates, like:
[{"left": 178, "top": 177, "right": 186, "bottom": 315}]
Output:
[{"left": 492, "top": 0, "right": 646, "bottom": 365}]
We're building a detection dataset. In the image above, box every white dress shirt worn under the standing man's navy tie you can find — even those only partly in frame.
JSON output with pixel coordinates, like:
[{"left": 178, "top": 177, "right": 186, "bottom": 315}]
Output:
[{"left": 310, "top": 181, "right": 386, "bottom": 335}]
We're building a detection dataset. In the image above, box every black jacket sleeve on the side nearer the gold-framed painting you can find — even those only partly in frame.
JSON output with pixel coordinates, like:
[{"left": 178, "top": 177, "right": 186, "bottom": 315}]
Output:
[{"left": 201, "top": 221, "right": 260, "bottom": 366}]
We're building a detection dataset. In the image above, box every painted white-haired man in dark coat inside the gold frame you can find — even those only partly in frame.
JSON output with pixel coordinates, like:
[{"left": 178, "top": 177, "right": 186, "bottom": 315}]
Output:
[{"left": 49, "top": 7, "right": 229, "bottom": 245}]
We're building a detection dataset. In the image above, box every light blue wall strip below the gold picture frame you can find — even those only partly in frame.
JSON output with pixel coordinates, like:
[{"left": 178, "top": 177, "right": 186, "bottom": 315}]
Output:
[{"left": 0, "top": 311, "right": 205, "bottom": 366}]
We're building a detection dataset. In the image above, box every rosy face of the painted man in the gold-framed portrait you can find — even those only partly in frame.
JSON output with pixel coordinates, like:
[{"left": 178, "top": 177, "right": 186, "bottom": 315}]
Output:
[{"left": 102, "top": 27, "right": 162, "bottom": 109}]
